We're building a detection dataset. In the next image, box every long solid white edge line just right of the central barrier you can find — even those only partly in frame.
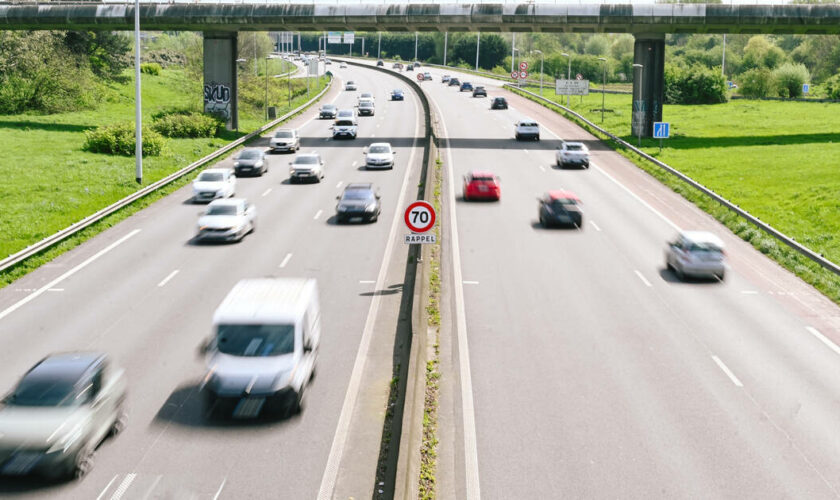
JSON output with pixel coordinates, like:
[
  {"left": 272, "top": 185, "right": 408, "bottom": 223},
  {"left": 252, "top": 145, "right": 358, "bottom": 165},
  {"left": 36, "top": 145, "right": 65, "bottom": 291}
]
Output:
[{"left": 434, "top": 94, "right": 481, "bottom": 500}]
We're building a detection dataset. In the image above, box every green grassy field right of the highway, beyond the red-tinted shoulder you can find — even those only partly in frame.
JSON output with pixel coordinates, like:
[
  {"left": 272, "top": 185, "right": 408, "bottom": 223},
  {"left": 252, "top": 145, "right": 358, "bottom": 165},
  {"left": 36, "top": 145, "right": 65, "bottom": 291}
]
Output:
[{"left": 520, "top": 89, "right": 840, "bottom": 303}]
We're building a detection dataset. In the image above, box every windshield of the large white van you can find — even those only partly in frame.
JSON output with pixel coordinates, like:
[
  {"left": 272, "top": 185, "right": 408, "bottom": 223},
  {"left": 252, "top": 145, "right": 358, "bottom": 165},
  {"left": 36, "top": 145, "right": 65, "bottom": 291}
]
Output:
[{"left": 216, "top": 325, "right": 295, "bottom": 357}]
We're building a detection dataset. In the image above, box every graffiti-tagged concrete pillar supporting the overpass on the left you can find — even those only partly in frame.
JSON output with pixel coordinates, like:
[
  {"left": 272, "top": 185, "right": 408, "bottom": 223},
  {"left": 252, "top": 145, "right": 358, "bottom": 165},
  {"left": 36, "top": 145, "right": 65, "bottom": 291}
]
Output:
[{"left": 204, "top": 31, "right": 239, "bottom": 130}]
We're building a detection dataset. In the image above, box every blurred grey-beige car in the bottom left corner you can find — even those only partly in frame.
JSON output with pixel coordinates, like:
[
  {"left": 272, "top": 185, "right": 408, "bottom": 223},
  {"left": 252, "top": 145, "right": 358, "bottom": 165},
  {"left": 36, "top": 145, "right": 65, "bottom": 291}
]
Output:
[{"left": 0, "top": 352, "right": 126, "bottom": 479}]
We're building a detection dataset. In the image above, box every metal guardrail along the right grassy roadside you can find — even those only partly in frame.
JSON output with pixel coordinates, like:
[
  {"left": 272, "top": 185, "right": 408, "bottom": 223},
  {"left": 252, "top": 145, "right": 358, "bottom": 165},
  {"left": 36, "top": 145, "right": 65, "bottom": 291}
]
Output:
[{"left": 504, "top": 84, "right": 840, "bottom": 275}]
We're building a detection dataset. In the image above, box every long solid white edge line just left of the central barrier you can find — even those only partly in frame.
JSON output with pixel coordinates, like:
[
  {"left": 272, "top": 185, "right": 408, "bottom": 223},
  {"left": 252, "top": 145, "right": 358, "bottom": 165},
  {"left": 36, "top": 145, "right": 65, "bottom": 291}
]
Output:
[{"left": 318, "top": 77, "right": 420, "bottom": 500}]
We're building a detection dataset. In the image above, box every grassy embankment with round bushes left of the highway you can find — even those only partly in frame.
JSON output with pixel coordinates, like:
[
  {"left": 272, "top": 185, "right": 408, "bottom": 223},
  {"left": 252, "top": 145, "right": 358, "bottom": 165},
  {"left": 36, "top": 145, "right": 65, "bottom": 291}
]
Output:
[{"left": 0, "top": 69, "right": 326, "bottom": 286}]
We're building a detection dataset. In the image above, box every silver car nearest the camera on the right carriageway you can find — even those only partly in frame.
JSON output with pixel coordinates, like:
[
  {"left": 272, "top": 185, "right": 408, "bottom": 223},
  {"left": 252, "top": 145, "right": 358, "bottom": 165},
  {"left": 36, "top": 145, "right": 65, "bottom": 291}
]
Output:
[{"left": 665, "top": 231, "right": 726, "bottom": 281}]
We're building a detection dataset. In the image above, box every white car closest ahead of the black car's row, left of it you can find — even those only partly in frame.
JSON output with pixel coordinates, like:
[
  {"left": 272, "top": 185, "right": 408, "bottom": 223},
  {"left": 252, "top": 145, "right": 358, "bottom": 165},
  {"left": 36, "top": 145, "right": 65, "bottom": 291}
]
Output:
[{"left": 196, "top": 198, "right": 257, "bottom": 241}]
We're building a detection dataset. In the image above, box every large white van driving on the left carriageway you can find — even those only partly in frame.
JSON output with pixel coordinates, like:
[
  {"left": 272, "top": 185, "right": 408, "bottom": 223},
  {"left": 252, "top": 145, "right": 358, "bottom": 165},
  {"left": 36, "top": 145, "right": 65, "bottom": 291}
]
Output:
[{"left": 202, "top": 278, "right": 321, "bottom": 418}]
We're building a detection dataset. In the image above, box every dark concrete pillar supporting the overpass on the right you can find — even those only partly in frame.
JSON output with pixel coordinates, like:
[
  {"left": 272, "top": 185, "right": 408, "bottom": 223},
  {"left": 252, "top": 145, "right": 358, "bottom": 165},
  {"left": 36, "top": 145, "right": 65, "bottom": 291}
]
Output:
[{"left": 630, "top": 33, "right": 665, "bottom": 137}]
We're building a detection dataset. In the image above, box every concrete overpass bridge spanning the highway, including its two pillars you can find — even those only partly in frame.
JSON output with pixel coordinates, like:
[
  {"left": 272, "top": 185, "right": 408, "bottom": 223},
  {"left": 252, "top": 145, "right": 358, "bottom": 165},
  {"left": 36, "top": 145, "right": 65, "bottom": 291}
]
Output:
[{"left": 0, "top": 0, "right": 840, "bottom": 136}]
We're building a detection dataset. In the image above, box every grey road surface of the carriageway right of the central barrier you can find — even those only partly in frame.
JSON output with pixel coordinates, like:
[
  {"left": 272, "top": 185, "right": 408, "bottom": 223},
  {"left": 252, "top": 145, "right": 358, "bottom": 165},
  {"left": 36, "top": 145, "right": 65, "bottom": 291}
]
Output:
[{"left": 408, "top": 68, "right": 840, "bottom": 499}]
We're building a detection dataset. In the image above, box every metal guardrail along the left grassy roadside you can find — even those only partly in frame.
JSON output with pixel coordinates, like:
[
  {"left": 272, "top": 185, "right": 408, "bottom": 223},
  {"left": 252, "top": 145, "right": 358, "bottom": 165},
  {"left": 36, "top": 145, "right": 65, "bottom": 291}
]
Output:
[{"left": 0, "top": 79, "right": 332, "bottom": 272}]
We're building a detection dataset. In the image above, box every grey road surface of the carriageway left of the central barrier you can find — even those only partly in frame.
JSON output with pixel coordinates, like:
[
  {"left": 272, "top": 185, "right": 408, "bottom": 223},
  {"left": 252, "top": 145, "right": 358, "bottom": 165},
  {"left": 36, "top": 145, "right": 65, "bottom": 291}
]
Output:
[{"left": 0, "top": 64, "right": 424, "bottom": 500}]
